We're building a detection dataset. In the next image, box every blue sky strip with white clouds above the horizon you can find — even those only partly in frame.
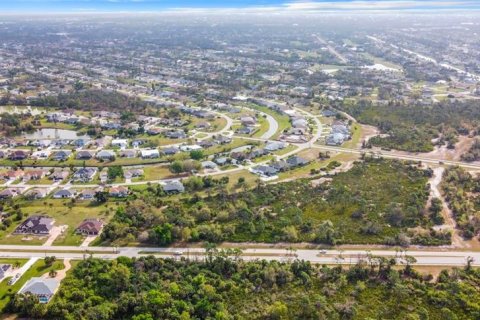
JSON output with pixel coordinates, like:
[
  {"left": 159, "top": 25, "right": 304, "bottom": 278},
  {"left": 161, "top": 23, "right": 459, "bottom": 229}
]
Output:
[{"left": 0, "top": 0, "right": 480, "bottom": 13}]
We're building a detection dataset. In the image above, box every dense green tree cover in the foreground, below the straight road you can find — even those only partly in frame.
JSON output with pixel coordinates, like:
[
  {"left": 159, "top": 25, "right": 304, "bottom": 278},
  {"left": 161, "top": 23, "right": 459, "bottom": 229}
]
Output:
[{"left": 9, "top": 251, "right": 480, "bottom": 320}]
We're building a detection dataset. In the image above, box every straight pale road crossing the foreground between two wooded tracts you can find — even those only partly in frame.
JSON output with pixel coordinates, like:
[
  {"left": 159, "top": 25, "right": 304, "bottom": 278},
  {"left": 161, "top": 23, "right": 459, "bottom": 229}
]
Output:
[{"left": 0, "top": 245, "right": 480, "bottom": 266}]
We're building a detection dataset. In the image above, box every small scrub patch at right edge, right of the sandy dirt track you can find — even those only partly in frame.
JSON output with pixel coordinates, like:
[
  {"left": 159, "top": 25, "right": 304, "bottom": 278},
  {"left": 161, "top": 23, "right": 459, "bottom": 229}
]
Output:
[{"left": 442, "top": 167, "right": 480, "bottom": 238}]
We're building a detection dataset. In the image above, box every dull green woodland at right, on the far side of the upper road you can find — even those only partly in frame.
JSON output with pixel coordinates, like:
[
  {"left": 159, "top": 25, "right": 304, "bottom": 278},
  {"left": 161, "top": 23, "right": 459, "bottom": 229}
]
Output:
[{"left": 339, "top": 100, "right": 480, "bottom": 152}]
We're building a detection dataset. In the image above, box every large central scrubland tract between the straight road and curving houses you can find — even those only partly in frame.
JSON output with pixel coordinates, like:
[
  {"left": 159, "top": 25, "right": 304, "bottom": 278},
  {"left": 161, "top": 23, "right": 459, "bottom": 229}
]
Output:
[{"left": 101, "top": 159, "right": 450, "bottom": 245}]
